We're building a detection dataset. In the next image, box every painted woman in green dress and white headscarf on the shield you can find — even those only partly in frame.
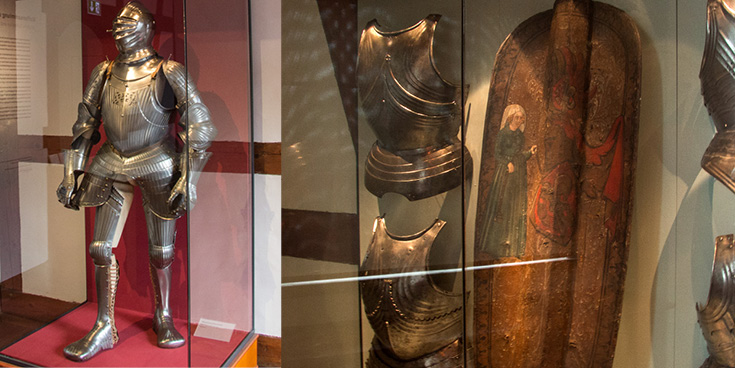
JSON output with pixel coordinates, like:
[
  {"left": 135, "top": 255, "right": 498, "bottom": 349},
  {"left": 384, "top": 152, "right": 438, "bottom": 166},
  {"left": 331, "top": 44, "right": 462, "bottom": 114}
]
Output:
[{"left": 478, "top": 104, "right": 538, "bottom": 258}]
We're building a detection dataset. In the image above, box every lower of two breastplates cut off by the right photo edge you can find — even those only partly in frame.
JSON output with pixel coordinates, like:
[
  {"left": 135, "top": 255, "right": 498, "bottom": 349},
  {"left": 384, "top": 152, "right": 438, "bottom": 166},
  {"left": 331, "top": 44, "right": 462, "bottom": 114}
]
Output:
[{"left": 697, "top": 234, "right": 735, "bottom": 367}]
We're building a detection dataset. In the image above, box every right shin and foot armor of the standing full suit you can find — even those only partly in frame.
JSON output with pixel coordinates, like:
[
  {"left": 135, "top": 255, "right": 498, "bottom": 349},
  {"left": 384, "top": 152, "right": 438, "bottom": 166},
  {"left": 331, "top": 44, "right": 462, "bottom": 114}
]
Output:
[{"left": 149, "top": 264, "right": 185, "bottom": 348}]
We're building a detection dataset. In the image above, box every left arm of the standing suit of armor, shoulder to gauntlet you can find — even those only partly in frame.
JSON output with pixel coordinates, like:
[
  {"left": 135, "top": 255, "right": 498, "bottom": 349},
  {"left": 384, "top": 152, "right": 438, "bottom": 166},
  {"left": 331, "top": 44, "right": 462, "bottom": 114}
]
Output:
[{"left": 56, "top": 61, "right": 111, "bottom": 210}]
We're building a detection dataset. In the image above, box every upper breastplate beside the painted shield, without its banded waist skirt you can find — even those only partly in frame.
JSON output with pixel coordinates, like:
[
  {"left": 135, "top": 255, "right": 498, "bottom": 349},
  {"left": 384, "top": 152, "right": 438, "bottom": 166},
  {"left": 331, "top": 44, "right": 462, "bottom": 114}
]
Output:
[{"left": 358, "top": 15, "right": 461, "bottom": 151}]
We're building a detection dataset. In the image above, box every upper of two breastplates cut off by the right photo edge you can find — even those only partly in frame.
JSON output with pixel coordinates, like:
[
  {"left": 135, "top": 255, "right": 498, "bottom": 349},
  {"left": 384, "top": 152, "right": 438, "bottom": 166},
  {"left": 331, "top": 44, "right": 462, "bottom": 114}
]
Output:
[{"left": 699, "top": 0, "right": 735, "bottom": 192}]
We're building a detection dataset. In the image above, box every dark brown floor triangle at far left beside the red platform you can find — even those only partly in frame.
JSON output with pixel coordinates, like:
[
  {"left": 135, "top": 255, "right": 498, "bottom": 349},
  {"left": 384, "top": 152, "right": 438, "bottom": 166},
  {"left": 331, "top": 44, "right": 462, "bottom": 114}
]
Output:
[{"left": 0, "top": 288, "right": 79, "bottom": 350}]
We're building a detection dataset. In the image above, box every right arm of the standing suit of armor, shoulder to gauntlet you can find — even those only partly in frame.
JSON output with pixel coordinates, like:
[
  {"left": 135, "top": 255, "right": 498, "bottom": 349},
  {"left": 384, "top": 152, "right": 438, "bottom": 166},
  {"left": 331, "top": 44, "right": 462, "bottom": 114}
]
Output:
[{"left": 163, "top": 60, "right": 217, "bottom": 212}]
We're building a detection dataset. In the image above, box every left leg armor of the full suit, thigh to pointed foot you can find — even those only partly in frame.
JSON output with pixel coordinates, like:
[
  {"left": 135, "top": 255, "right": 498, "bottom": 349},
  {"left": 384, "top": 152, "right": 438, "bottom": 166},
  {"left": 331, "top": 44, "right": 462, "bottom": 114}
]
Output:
[{"left": 64, "top": 189, "right": 123, "bottom": 361}]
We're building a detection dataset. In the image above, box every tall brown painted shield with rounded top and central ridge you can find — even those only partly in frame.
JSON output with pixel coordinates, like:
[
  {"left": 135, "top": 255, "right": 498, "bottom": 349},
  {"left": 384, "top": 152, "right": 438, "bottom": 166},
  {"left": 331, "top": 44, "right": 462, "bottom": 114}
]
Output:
[{"left": 474, "top": 0, "right": 641, "bottom": 368}]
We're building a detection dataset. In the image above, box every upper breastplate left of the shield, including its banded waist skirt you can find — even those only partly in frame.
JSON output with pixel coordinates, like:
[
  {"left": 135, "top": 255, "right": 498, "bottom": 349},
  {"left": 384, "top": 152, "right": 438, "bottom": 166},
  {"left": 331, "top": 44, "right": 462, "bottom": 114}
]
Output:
[{"left": 357, "top": 14, "right": 472, "bottom": 200}]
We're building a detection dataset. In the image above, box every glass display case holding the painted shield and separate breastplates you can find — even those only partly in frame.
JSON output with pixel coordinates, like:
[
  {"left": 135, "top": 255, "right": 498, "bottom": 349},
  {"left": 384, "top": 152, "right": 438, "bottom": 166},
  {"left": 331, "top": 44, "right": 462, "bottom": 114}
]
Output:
[{"left": 281, "top": 0, "right": 720, "bottom": 367}]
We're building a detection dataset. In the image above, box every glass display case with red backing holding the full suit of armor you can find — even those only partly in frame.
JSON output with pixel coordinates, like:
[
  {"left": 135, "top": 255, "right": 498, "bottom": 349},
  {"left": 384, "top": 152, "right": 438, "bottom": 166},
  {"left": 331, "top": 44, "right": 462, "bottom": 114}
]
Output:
[{"left": 0, "top": 0, "right": 254, "bottom": 367}]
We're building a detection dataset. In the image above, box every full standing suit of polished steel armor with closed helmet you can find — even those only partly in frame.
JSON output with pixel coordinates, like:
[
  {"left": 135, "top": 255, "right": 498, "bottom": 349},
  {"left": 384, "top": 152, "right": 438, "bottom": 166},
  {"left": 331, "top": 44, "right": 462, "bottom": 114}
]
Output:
[{"left": 57, "top": 1, "right": 217, "bottom": 361}]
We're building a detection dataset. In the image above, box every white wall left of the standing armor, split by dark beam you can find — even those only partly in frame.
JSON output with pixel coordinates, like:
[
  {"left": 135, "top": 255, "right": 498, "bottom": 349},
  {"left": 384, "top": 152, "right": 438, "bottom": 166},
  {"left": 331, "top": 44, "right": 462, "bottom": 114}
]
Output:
[{"left": 6, "top": 0, "right": 87, "bottom": 302}]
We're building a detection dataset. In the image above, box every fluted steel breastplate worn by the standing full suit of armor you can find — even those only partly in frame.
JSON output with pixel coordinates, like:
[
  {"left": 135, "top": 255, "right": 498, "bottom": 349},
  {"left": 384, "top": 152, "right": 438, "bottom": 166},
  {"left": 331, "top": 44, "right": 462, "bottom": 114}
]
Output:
[{"left": 100, "top": 58, "right": 173, "bottom": 156}]
